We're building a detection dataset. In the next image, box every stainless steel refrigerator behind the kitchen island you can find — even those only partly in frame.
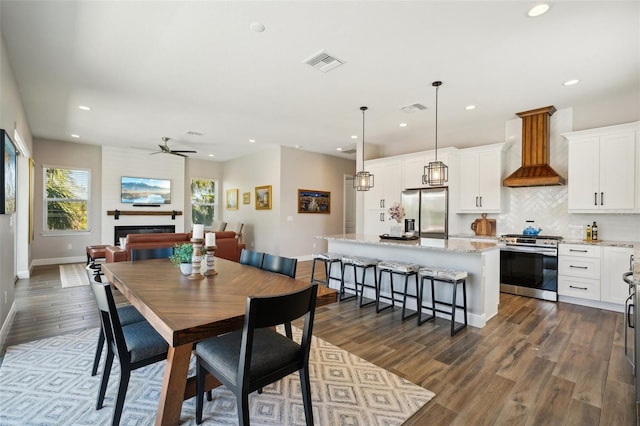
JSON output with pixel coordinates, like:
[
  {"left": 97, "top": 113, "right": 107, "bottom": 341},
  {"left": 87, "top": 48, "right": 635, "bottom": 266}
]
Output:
[{"left": 402, "top": 187, "right": 449, "bottom": 240}]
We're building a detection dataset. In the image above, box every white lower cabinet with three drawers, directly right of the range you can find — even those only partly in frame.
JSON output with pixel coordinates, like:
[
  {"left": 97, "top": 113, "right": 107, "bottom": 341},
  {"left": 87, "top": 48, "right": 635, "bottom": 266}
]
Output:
[{"left": 558, "top": 244, "right": 600, "bottom": 301}]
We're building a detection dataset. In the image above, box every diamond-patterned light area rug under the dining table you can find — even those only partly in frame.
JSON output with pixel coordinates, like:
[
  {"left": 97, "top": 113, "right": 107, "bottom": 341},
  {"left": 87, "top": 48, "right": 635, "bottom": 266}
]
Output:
[{"left": 0, "top": 329, "right": 435, "bottom": 426}]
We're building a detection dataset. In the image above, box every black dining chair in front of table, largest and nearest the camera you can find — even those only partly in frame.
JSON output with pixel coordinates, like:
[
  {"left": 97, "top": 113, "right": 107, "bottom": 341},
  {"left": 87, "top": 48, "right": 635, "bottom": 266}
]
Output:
[{"left": 195, "top": 284, "right": 318, "bottom": 426}]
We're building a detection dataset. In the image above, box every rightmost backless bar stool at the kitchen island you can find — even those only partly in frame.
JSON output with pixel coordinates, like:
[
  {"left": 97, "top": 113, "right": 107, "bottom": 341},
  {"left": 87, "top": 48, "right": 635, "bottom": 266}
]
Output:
[{"left": 418, "top": 267, "right": 467, "bottom": 336}]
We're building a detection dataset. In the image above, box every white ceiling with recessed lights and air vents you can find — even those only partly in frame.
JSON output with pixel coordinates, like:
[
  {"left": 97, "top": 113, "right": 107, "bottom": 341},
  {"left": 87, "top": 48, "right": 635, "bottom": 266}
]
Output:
[{"left": 0, "top": 0, "right": 640, "bottom": 161}]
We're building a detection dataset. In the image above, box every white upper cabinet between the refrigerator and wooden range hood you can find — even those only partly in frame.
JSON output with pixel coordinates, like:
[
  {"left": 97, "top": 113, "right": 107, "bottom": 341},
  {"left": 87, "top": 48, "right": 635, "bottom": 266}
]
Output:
[{"left": 458, "top": 143, "right": 506, "bottom": 213}]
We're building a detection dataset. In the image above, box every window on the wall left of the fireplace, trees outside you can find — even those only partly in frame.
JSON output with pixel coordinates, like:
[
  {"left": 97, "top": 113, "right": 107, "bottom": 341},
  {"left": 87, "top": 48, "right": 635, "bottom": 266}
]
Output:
[{"left": 43, "top": 166, "right": 91, "bottom": 233}]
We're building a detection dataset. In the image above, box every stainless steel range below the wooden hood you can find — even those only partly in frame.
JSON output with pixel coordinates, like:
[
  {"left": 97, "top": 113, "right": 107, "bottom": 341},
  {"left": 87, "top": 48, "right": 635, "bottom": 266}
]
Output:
[{"left": 499, "top": 234, "right": 562, "bottom": 302}]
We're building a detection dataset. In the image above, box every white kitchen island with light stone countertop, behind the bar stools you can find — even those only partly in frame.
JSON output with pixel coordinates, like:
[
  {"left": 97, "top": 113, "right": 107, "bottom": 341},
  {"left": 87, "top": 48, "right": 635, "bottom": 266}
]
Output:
[{"left": 318, "top": 234, "right": 500, "bottom": 328}]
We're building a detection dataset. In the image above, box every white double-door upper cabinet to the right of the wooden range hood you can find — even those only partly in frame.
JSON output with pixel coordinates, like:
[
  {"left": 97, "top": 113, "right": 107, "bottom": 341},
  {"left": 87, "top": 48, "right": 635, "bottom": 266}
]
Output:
[{"left": 562, "top": 122, "right": 640, "bottom": 213}]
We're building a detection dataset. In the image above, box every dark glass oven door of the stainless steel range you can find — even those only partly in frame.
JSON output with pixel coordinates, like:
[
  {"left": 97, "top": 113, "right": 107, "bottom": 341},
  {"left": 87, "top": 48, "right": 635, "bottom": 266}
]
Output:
[{"left": 500, "top": 246, "right": 558, "bottom": 302}]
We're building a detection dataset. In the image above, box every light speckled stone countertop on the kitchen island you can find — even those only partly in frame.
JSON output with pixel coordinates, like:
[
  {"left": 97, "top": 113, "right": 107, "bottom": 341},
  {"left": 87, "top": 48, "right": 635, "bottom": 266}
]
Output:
[{"left": 318, "top": 234, "right": 500, "bottom": 254}]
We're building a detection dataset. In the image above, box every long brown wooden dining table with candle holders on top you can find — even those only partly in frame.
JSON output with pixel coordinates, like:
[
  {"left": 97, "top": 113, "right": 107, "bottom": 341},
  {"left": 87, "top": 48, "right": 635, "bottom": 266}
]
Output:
[{"left": 102, "top": 258, "right": 337, "bottom": 425}]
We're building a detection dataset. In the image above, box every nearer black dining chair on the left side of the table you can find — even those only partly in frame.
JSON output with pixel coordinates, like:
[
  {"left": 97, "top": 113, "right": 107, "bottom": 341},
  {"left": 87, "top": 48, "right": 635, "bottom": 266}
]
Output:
[{"left": 90, "top": 272, "right": 169, "bottom": 425}]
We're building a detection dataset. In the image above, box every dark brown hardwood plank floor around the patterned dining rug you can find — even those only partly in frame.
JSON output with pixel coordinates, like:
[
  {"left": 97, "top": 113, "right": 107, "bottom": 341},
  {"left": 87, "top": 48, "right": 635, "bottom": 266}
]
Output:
[{"left": 0, "top": 262, "right": 636, "bottom": 426}]
